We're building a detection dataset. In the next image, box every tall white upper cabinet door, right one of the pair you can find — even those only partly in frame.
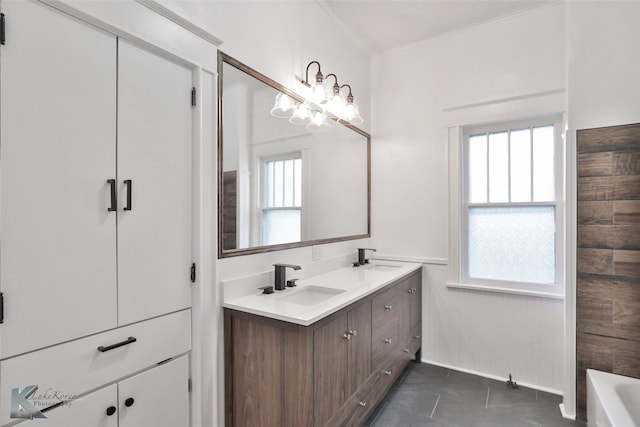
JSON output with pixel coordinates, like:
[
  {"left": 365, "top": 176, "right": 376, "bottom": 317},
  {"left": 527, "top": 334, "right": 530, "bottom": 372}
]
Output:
[{"left": 118, "top": 40, "right": 192, "bottom": 325}]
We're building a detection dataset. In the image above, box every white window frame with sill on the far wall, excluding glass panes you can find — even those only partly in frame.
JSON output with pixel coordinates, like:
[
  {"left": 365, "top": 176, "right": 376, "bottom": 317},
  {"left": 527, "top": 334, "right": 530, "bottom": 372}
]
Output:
[{"left": 447, "top": 115, "right": 565, "bottom": 299}]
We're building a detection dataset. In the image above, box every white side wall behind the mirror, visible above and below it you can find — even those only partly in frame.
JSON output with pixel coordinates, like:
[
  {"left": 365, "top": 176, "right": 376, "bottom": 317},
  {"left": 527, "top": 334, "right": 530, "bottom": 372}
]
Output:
[{"left": 160, "top": 0, "right": 371, "bottom": 426}]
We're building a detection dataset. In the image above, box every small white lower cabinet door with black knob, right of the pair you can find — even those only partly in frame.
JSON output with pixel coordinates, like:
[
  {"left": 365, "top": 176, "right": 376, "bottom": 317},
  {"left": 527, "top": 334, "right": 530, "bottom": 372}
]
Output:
[{"left": 118, "top": 356, "right": 190, "bottom": 427}]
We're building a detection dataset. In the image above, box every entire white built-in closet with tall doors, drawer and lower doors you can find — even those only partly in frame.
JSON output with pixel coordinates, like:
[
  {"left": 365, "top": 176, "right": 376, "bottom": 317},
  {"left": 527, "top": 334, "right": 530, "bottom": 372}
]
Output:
[{"left": 0, "top": 0, "right": 194, "bottom": 427}]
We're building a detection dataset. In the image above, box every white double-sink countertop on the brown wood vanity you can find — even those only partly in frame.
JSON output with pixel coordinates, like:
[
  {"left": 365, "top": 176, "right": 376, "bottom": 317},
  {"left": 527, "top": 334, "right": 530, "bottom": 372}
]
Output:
[{"left": 222, "top": 260, "right": 422, "bottom": 326}]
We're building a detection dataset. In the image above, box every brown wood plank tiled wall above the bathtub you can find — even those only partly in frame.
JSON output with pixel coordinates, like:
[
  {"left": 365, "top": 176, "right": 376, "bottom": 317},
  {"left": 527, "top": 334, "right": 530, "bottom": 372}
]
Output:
[{"left": 576, "top": 124, "right": 640, "bottom": 420}]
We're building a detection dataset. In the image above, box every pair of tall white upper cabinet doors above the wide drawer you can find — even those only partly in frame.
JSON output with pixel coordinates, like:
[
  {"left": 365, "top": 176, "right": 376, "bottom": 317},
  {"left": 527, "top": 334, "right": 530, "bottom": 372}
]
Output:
[{"left": 0, "top": 2, "right": 192, "bottom": 358}]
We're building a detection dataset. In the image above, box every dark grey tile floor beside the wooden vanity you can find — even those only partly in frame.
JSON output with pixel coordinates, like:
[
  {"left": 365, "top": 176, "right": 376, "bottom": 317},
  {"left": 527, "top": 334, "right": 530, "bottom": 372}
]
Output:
[{"left": 365, "top": 362, "right": 586, "bottom": 427}]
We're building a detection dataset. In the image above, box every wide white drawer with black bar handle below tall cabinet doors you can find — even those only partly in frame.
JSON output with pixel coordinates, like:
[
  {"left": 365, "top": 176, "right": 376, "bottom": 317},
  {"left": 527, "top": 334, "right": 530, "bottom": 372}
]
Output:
[{"left": 0, "top": 310, "right": 191, "bottom": 425}]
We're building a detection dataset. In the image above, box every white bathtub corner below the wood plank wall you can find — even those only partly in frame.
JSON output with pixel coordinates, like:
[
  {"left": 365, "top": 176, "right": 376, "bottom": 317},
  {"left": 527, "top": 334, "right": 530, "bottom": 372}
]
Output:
[{"left": 587, "top": 369, "right": 640, "bottom": 427}]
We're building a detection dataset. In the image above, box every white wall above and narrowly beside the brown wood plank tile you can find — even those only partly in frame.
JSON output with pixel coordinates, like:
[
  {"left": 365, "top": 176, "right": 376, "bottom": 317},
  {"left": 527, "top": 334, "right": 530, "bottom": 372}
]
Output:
[{"left": 565, "top": 1, "right": 640, "bottom": 414}]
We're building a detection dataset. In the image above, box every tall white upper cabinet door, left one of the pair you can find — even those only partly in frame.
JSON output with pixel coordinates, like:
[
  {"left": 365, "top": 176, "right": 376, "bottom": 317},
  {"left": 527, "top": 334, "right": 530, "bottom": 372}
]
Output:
[{"left": 0, "top": 1, "right": 117, "bottom": 358}]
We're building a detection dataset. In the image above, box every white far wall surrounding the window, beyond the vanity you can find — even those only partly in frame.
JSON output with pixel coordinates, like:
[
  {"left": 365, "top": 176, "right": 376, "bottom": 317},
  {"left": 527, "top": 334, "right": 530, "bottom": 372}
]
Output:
[{"left": 372, "top": 4, "right": 567, "bottom": 391}]
